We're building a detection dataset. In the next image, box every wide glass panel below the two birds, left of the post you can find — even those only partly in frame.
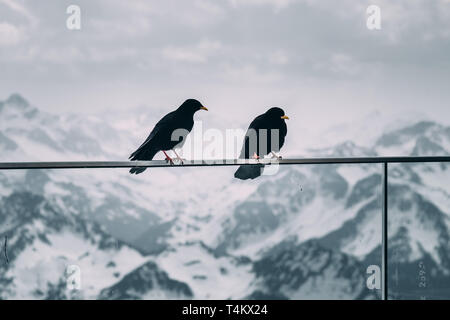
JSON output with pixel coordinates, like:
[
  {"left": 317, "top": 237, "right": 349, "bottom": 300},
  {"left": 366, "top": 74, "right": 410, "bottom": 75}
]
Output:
[{"left": 0, "top": 165, "right": 381, "bottom": 299}]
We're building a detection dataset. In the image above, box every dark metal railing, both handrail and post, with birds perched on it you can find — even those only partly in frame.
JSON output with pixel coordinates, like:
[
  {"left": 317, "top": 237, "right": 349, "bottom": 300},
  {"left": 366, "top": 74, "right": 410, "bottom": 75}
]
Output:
[{"left": 0, "top": 156, "right": 450, "bottom": 300}]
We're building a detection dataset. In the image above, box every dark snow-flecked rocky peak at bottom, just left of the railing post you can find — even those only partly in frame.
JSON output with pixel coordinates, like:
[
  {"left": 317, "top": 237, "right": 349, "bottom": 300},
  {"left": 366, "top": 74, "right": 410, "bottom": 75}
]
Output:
[{"left": 250, "top": 241, "right": 371, "bottom": 299}]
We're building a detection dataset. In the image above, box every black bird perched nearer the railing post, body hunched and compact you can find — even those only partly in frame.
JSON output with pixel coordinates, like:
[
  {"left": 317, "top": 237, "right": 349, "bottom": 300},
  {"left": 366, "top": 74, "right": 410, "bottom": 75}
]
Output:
[{"left": 234, "top": 107, "right": 289, "bottom": 180}]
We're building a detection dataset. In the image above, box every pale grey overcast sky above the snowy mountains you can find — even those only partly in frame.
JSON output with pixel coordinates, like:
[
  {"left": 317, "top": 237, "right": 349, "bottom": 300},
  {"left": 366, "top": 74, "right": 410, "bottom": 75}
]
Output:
[{"left": 0, "top": 0, "right": 450, "bottom": 136}]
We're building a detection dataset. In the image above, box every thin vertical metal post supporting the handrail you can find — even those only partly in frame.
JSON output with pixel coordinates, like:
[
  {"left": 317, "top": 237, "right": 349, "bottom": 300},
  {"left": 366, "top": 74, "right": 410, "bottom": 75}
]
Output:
[{"left": 381, "top": 162, "right": 388, "bottom": 300}]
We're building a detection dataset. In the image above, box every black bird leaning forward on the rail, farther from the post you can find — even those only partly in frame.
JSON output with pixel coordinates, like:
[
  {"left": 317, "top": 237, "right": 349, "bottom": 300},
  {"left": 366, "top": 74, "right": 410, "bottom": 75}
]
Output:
[{"left": 129, "top": 99, "right": 208, "bottom": 174}]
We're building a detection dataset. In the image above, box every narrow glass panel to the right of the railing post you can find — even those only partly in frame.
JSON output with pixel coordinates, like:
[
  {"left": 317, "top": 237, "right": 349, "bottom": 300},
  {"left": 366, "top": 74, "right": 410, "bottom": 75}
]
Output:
[{"left": 388, "top": 163, "right": 450, "bottom": 299}]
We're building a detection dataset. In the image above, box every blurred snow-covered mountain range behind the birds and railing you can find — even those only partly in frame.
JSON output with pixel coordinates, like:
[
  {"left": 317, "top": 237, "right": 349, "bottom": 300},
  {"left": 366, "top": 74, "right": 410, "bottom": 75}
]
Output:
[{"left": 0, "top": 94, "right": 450, "bottom": 299}]
